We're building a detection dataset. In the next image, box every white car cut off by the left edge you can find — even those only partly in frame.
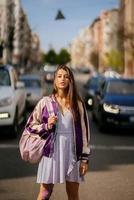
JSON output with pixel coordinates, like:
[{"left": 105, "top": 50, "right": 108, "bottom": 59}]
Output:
[{"left": 0, "top": 65, "right": 26, "bottom": 137}]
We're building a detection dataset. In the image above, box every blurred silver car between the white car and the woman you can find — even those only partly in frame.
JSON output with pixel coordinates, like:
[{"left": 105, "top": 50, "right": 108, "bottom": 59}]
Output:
[{"left": 20, "top": 74, "right": 46, "bottom": 107}]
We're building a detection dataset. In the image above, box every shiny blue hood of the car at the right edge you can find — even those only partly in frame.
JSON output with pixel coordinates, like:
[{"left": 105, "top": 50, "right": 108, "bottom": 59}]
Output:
[{"left": 104, "top": 94, "right": 134, "bottom": 106}]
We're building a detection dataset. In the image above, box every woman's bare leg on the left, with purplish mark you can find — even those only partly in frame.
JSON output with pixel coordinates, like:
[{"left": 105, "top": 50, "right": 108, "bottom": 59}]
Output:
[{"left": 37, "top": 183, "right": 54, "bottom": 200}]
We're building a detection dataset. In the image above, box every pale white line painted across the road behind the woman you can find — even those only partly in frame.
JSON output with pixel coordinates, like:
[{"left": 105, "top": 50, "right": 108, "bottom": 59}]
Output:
[{"left": 0, "top": 144, "right": 134, "bottom": 151}]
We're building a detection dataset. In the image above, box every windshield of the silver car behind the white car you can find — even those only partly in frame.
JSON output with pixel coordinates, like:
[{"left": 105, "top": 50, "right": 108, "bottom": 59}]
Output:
[{"left": 21, "top": 79, "right": 41, "bottom": 88}]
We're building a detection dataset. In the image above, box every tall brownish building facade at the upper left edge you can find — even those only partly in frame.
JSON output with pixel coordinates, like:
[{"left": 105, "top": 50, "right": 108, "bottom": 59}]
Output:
[{"left": 0, "top": 0, "right": 41, "bottom": 68}]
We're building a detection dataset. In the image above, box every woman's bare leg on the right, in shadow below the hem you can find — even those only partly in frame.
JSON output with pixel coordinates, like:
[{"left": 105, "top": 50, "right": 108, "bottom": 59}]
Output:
[{"left": 66, "top": 181, "right": 79, "bottom": 200}]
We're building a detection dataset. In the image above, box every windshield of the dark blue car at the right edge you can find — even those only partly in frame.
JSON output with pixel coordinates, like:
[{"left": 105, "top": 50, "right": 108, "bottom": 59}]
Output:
[{"left": 107, "top": 81, "right": 134, "bottom": 95}]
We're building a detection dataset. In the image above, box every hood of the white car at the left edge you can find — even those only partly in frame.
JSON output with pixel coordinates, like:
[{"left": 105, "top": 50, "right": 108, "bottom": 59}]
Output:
[{"left": 0, "top": 86, "right": 13, "bottom": 100}]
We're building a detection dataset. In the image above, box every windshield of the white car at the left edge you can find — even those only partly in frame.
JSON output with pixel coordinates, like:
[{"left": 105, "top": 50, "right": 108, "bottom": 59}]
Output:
[{"left": 0, "top": 68, "right": 11, "bottom": 86}]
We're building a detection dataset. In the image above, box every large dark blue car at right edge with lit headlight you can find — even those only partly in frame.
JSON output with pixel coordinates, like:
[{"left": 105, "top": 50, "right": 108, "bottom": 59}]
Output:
[{"left": 93, "top": 78, "right": 134, "bottom": 130}]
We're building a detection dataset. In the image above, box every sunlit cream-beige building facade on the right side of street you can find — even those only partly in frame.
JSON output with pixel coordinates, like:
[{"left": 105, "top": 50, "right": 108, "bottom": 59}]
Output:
[{"left": 99, "top": 9, "right": 120, "bottom": 72}]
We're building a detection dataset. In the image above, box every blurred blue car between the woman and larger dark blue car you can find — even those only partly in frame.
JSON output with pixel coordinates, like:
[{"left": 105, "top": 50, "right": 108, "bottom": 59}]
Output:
[{"left": 84, "top": 75, "right": 103, "bottom": 109}]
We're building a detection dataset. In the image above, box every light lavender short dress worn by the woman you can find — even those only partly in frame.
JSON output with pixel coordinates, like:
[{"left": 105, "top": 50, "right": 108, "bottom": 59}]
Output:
[{"left": 37, "top": 109, "right": 84, "bottom": 184}]
